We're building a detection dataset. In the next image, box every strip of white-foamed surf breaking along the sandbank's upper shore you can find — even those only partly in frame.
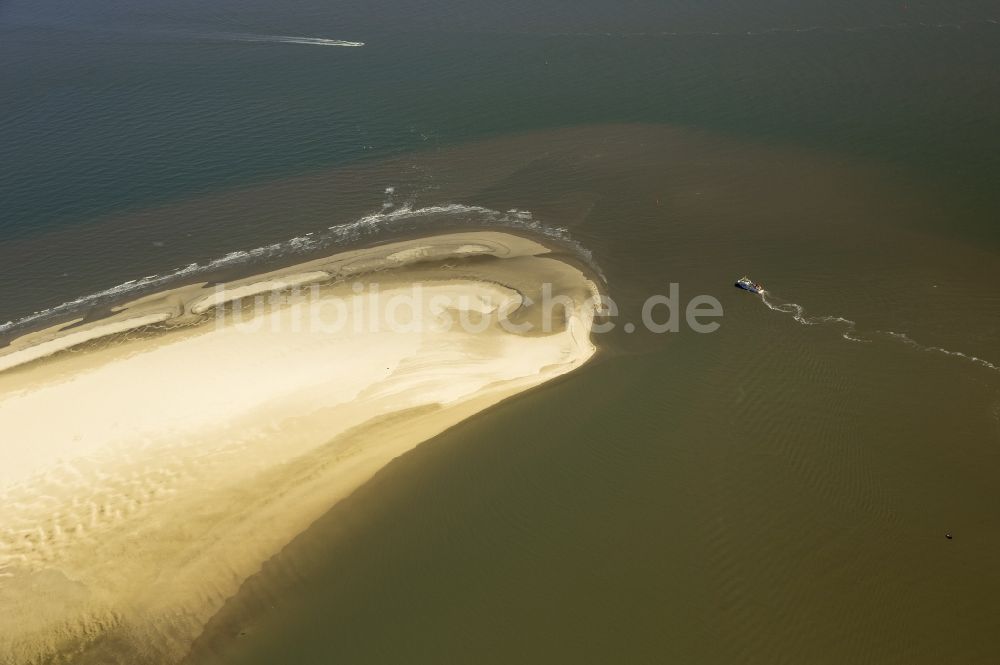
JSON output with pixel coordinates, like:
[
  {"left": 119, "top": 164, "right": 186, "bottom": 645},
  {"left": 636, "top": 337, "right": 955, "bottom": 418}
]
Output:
[{"left": 0, "top": 199, "right": 607, "bottom": 336}]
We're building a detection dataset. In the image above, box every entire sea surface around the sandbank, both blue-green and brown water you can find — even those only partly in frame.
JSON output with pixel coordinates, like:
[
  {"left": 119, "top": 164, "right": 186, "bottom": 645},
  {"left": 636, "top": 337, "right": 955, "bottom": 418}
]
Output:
[{"left": 0, "top": 0, "right": 1000, "bottom": 665}]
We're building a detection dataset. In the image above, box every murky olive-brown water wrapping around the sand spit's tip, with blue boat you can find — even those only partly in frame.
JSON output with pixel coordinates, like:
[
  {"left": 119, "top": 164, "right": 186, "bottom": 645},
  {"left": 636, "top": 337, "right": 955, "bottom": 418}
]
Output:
[{"left": 148, "top": 126, "right": 1000, "bottom": 663}]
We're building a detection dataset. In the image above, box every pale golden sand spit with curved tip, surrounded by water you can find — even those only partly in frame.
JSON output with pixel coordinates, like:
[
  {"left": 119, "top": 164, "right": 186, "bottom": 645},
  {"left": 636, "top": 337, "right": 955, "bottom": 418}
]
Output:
[{"left": 0, "top": 231, "right": 597, "bottom": 664}]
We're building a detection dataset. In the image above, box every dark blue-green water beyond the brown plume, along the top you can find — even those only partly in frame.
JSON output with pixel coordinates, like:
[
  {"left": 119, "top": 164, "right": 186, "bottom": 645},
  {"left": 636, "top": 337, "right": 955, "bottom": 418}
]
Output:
[{"left": 0, "top": 2, "right": 1000, "bottom": 246}]
